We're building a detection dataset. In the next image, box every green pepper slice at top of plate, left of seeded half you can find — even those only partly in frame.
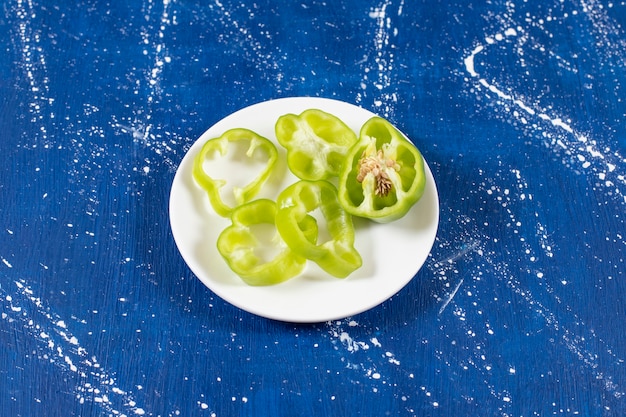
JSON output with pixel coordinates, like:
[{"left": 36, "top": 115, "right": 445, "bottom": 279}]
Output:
[{"left": 274, "top": 109, "right": 357, "bottom": 181}]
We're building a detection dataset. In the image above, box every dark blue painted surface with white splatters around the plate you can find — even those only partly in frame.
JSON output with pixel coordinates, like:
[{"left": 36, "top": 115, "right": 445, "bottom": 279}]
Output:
[{"left": 0, "top": 0, "right": 626, "bottom": 417}]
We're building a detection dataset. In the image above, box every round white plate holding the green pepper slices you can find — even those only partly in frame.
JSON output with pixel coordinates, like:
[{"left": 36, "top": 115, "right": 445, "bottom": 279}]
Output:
[{"left": 169, "top": 97, "right": 439, "bottom": 323}]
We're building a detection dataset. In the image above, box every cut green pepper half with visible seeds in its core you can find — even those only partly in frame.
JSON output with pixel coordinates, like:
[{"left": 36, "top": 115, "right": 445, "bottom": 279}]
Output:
[{"left": 338, "top": 116, "right": 426, "bottom": 223}]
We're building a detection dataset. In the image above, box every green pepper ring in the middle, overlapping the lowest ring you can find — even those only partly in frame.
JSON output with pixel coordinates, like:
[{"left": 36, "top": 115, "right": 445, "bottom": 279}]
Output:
[{"left": 276, "top": 180, "right": 363, "bottom": 278}]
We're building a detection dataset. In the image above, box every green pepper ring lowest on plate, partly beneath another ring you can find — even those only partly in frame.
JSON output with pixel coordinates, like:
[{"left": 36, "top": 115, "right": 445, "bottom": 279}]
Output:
[{"left": 217, "top": 198, "right": 318, "bottom": 286}]
